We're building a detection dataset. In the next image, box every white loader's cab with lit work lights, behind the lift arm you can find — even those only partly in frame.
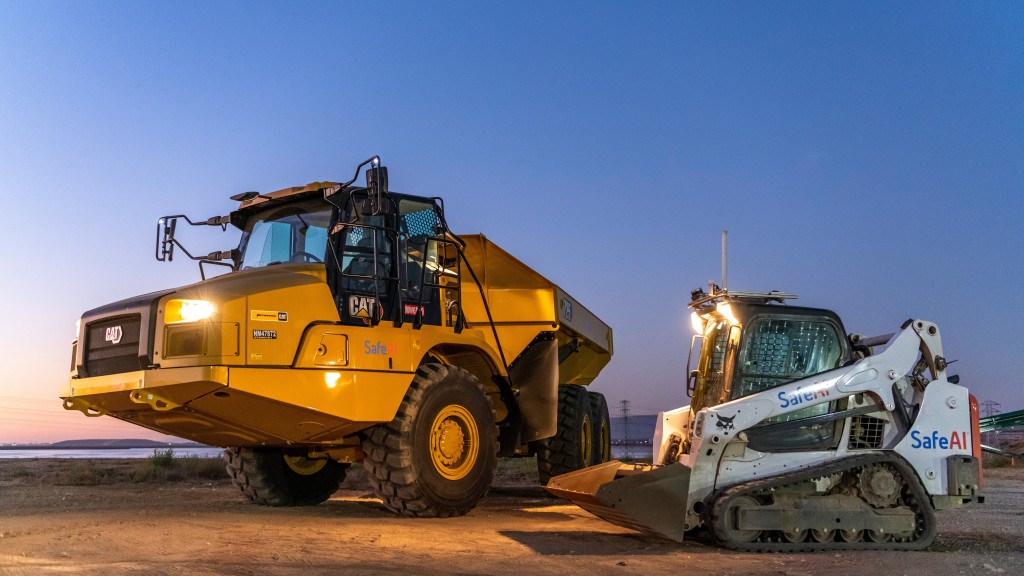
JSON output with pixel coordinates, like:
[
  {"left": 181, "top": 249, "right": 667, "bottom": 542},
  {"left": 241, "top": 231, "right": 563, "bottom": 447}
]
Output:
[{"left": 687, "top": 291, "right": 852, "bottom": 452}]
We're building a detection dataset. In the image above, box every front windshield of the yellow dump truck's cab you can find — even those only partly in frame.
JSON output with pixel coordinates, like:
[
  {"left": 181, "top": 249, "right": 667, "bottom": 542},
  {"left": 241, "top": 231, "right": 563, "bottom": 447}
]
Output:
[{"left": 240, "top": 202, "right": 331, "bottom": 270}]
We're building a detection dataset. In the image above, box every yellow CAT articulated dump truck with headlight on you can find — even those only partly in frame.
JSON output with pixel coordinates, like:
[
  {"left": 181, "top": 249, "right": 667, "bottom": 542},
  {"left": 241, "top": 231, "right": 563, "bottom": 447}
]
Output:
[{"left": 61, "top": 157, "right": 612, "bottom": 517}]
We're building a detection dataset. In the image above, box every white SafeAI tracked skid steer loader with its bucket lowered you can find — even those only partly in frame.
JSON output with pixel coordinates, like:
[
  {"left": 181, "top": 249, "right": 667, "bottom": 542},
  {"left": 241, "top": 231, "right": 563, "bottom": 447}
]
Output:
[{"left": 547, "top": 285, "right": 984, "bottom": 551}]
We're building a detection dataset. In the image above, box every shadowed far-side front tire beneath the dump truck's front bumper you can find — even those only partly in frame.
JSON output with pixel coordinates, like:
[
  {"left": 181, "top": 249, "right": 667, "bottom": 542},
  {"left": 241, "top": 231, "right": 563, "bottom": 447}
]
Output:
[{"left": 224, "top": 448, "right": 348, "bottom": 506}]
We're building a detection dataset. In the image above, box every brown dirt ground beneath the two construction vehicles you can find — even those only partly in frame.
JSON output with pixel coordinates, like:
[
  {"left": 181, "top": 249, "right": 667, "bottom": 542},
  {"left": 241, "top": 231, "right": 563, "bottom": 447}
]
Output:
[{"left": 0, "top": 460, "right": 1024, "bottom": 576}]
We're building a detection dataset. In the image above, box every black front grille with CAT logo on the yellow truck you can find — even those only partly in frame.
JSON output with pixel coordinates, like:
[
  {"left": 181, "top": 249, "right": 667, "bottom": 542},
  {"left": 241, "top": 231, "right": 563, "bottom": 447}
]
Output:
[{"left": 84, "top": 314, "right": 148, "bottom": 376}]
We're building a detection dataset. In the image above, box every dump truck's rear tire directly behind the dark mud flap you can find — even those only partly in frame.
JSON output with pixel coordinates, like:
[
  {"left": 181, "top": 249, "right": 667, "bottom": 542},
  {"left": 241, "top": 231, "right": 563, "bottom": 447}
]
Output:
[{"left": 536, "top": 384, "right": 594, "bottom": 484}]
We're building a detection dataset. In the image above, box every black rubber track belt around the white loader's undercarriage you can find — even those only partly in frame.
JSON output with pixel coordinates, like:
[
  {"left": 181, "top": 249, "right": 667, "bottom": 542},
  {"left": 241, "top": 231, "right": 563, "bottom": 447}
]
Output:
[{"left": 711, "top": 454, "right": 936, "bottom": 552}]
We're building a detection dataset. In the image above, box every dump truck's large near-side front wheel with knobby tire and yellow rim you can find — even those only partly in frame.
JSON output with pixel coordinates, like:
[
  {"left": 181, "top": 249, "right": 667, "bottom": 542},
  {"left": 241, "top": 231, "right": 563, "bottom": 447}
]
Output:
[{"left": 362, "top": 364, "right": 498, "bottom": 518}]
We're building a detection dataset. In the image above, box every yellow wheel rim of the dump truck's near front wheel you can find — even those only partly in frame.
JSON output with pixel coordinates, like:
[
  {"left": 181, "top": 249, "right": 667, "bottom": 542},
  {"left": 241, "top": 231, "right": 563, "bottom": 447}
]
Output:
[{"left": 430, "top": 404, "right": 480, "bottom": 480}]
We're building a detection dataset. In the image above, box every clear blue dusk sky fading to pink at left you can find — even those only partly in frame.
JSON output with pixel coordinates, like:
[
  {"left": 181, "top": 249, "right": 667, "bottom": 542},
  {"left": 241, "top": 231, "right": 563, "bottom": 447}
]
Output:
[{"left": 0, "top": 0, "right": 1024, "bottom": 442}]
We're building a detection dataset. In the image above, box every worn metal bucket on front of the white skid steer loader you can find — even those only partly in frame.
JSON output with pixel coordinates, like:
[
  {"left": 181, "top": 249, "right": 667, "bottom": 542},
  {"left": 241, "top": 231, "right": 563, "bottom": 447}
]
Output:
[{"left": 545, "top": 460, "right": 690, "bottom": 542}]
